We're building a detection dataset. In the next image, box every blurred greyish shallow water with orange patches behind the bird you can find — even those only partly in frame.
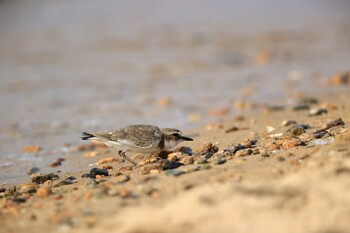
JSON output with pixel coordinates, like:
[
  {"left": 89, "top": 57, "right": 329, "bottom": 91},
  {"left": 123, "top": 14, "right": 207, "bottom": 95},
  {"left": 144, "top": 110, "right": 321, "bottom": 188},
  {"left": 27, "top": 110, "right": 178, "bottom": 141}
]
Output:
[{"left": 0, "top": 0, "right": 350, "bottom": 181}]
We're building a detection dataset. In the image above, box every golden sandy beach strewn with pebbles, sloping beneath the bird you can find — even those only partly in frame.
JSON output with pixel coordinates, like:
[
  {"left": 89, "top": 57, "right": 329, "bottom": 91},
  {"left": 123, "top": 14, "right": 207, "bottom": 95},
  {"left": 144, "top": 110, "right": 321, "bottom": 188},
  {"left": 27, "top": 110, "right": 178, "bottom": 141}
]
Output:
[{"left": 0, "top": 91, "right": 350, "bottom": 232}]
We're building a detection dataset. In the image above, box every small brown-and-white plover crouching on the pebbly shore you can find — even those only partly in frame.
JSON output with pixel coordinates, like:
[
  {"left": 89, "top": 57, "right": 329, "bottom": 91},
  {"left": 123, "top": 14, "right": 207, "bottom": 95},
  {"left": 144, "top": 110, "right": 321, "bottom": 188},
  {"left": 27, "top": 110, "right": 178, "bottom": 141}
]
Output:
[{"left": 81, "top": 125, "right": 193, "bottom": 165}]
